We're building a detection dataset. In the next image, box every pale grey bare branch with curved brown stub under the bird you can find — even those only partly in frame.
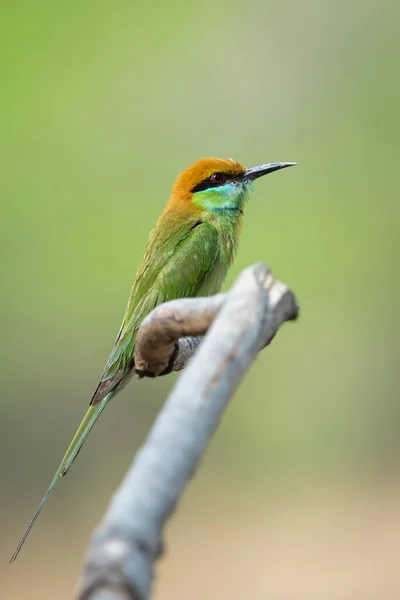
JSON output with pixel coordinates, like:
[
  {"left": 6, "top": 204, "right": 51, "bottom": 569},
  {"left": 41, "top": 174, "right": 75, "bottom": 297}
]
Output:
[{"left": 78, "top": 263, "right": 298, "bottom": 600}]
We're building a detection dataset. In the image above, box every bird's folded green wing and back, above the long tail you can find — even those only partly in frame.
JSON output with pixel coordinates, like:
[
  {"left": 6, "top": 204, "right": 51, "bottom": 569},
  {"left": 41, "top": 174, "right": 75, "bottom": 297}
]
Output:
[{"left": 92, "top": 221, "right": 219, "bottom": 404}]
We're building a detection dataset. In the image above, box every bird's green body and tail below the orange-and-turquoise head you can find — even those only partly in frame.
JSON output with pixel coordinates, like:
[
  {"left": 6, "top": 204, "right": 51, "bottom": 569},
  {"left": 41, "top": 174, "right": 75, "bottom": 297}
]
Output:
[{"left": 10, "top": 205, "right": 239, "bottom": 562}]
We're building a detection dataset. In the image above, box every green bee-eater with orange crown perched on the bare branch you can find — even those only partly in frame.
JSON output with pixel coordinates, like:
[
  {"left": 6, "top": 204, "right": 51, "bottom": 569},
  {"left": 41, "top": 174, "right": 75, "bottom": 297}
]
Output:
[{"left": 10, "top": 158, "right": 297, "bottom": 563}]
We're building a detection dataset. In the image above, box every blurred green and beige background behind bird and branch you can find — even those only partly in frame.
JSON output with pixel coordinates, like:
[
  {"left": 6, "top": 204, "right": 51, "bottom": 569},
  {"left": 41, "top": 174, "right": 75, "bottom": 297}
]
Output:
[{"left": 0, "top": 0, "right": 400, "bottom": 600}]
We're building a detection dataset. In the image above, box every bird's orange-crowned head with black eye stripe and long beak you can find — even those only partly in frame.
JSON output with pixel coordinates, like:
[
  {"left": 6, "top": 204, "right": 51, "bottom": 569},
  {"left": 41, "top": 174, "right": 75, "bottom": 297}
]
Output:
[{"left": 172, "top": 158, "right": 296, "bottom": 212}]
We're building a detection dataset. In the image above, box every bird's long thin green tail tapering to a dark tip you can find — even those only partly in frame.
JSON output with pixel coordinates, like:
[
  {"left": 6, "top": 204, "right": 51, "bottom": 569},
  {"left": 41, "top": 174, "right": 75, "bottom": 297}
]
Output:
[{"left": 10, "top": 392, "right": 114, "bottom": 563}]
